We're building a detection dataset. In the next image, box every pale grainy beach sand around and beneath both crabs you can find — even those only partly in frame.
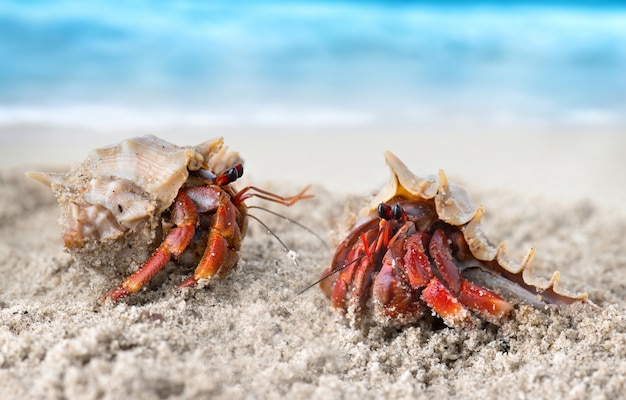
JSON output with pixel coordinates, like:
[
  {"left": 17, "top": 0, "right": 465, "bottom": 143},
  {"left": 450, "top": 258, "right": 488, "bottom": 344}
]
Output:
[{"left": 0, "top": 128, "right": 626, "bottom": 399}]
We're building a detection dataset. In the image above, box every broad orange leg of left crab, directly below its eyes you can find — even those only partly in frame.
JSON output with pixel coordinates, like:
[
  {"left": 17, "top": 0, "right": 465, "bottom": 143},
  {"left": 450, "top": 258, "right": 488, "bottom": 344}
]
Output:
[{"left": 178, "top": 189, "right": 241, "bottom": 288}]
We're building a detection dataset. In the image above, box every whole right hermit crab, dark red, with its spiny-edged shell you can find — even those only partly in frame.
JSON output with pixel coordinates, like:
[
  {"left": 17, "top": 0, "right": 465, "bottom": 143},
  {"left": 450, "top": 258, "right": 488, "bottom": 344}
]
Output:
[{"left": 320, "top": 152, "right": 587, "bottom": 327}]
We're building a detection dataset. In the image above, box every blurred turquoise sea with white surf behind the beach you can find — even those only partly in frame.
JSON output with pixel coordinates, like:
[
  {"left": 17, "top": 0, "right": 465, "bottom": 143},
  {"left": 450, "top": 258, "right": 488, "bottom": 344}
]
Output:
[{"left": 0, "top": 0, "right": 626, "bottom": 124}]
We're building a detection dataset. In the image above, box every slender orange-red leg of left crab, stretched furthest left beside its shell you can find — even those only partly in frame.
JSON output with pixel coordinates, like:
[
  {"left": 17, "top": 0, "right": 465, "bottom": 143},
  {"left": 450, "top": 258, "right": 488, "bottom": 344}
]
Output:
[{"left": 105, "top": 192, "right": 198, "bottom": 300}]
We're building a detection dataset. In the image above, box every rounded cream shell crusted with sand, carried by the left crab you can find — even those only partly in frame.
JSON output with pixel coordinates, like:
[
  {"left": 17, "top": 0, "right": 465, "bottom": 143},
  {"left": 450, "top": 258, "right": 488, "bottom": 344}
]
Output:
[{"left": 26, "top": 135, "right": 241, "bottom": 272}]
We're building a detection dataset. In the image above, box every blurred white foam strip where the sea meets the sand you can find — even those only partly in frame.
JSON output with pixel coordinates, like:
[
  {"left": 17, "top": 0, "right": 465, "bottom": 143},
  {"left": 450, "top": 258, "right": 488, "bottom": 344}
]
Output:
[{"left": 0, "top": 103, "right": 626, "bottom": 132}]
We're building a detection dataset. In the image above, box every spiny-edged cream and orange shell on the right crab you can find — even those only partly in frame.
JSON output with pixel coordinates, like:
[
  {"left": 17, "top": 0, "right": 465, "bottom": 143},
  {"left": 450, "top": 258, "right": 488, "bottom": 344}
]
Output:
[{"left": 360, "top": 151, "right": 588, "bottom": 307}]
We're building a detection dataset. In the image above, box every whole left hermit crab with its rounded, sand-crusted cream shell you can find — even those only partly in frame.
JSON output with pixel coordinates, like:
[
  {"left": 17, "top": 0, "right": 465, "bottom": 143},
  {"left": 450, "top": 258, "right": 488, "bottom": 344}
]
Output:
[{"left": 27, "top": 136, "right": 312, "bottom": 300}]
